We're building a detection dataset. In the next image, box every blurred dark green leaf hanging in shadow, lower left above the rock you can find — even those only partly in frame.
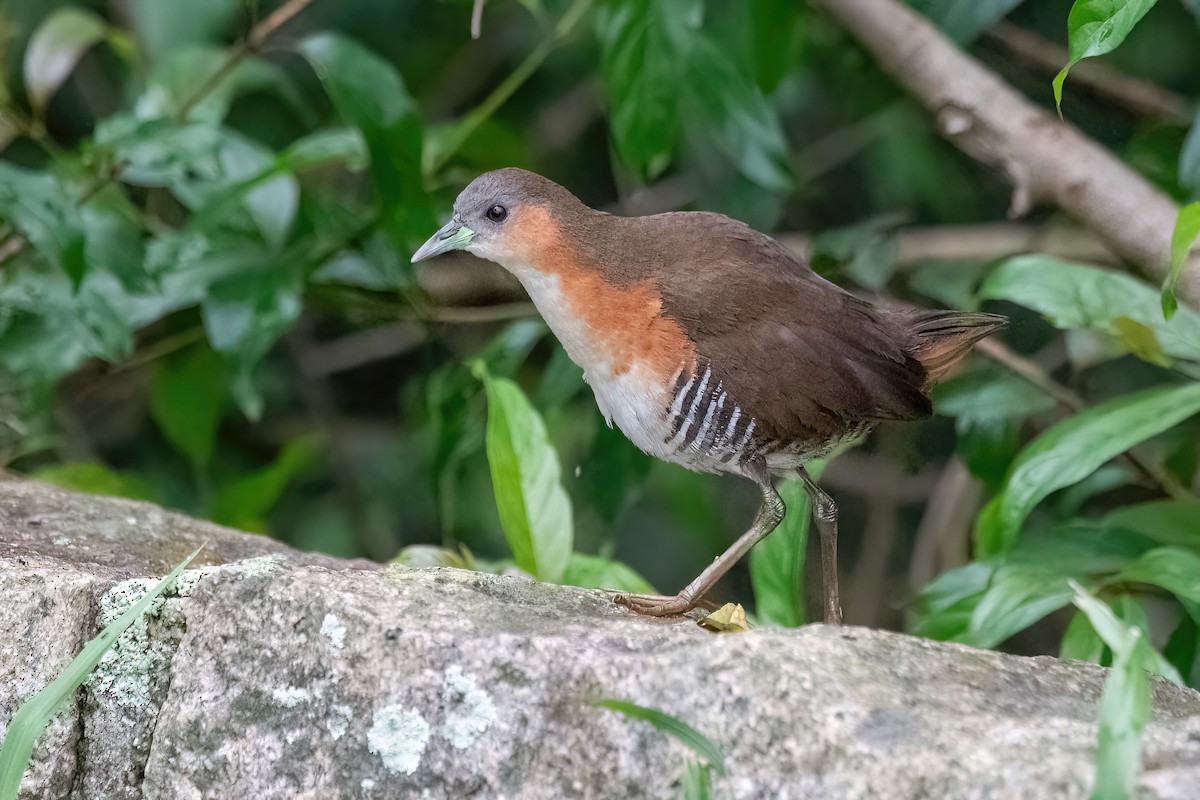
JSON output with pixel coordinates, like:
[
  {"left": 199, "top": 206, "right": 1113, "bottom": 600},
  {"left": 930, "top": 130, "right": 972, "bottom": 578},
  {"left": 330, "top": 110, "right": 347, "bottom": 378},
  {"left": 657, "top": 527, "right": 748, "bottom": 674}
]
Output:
[{"left": 150, "top": 348, "right": 226, "bottom": 469}]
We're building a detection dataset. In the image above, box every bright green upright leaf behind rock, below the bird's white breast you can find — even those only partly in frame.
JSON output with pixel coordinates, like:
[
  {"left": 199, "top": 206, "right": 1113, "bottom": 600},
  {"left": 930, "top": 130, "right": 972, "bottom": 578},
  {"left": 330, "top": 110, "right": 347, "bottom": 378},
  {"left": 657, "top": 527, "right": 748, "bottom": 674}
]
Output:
[{"left": 472, "top": 361, "right": 575, "bottom": 583}]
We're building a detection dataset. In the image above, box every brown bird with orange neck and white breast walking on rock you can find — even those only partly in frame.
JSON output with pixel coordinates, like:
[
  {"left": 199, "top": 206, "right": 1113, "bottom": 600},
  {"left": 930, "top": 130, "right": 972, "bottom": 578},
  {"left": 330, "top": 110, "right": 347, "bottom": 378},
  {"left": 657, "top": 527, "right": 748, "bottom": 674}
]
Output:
[{"left": 412, "top": 167, "right": 1007, "bottom": 625}]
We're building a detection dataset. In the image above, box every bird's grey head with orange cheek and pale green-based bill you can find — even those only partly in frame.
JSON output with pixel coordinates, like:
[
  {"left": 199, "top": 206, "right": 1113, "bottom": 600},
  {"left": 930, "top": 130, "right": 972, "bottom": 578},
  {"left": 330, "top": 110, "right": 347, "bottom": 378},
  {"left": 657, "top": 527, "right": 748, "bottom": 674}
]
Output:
[{"left": 413, "top": 167, "right": 586, "bottom": 266}]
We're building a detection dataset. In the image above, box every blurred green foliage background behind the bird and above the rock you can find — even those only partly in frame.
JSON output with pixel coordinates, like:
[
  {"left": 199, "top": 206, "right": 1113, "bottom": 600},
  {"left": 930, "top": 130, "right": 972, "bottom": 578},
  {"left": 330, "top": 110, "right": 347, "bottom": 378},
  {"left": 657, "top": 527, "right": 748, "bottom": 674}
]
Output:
[{"left": 0, "top": 0, "right": 1200, "bottom": 686}]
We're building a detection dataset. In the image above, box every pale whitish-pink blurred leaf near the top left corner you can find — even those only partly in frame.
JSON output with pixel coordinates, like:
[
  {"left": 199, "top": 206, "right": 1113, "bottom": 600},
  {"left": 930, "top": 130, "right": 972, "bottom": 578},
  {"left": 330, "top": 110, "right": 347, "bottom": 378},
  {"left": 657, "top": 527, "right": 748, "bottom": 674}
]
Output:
[{"left": 24, "top": 6, "right": 109, "bottom": 116}]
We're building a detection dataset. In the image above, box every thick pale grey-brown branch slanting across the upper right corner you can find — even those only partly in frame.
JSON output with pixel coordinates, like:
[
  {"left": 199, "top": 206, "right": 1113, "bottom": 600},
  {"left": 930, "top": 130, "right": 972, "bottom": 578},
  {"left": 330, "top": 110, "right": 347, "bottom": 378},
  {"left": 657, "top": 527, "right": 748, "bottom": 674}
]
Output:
[{"left": 815, "top": 0, "right": 1200, "bottom": 308}]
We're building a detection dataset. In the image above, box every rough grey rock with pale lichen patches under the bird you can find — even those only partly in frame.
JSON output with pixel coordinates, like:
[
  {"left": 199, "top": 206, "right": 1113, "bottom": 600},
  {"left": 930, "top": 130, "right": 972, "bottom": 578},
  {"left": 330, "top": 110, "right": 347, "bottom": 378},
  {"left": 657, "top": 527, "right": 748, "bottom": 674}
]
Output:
[{"left": 0, "top": 480, "right": 1200, "bottom": 800}]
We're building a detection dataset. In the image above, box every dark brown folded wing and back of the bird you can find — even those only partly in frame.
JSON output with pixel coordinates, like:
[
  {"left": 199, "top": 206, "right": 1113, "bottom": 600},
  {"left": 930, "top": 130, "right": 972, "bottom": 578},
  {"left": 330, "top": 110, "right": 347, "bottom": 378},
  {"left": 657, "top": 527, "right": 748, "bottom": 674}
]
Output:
[{"left": 653, "top": 213, "right": 930, "bottom": 444}]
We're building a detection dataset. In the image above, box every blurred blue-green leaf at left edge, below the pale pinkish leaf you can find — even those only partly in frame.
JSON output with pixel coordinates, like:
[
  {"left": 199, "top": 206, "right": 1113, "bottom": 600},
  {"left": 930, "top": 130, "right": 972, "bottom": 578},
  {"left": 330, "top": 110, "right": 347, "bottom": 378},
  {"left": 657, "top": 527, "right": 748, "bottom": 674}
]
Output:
[{"left": 0, "top": 162, "right": 86, "bottom": 287}]
